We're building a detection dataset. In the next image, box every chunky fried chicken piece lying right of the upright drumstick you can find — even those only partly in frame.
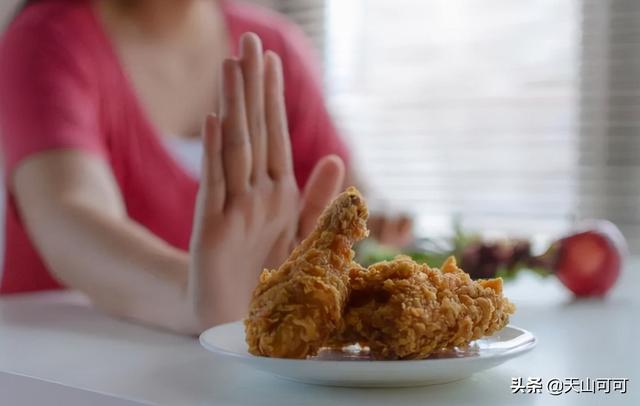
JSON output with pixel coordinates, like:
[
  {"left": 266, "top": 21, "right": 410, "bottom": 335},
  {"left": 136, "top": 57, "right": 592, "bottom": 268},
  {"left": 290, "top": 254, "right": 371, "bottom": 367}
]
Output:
[{"left": 332, "top": 256, "right": 515, "bottom": 359}]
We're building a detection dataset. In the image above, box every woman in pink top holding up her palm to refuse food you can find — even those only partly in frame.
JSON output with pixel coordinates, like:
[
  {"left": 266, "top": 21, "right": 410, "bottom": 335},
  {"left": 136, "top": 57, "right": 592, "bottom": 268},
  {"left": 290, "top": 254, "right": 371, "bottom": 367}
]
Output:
[{"left": 0, "top": 0, "right": 407, "bottom": 333}]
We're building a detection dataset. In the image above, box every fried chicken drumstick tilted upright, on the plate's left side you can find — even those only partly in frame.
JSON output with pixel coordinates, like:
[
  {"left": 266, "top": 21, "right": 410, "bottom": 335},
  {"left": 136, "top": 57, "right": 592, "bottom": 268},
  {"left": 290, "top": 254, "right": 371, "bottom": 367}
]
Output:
[{"left": 245, "top": 187, "right": 368, "bottom": 358}]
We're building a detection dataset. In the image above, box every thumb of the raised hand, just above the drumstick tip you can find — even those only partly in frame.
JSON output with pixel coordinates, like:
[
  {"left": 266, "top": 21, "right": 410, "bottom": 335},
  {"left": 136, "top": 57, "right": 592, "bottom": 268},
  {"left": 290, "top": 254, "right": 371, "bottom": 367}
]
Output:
[{"left": 298, "top": 155, "right": 345, "bottom": 239}]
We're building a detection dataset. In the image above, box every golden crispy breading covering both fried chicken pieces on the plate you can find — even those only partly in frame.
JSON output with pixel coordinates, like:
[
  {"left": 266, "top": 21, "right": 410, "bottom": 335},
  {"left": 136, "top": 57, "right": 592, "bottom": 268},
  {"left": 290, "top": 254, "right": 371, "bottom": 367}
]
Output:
[{"left": 245, "top": 188, "right": 515, "bottom": 359}]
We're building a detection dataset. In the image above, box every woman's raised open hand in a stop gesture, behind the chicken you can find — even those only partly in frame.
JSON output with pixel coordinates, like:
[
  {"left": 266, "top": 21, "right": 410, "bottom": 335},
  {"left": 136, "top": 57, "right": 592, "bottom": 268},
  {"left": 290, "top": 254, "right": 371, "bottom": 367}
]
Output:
[{"left": 188, "top": 34, "right": 344, "bottom": 327}]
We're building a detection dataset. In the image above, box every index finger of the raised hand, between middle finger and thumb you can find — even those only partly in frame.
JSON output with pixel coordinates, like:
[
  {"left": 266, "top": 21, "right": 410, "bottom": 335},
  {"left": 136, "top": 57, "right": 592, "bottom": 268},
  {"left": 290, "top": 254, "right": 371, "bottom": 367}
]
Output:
[{"left": 264, "top": 51, "right": 293, "bottom": 179}]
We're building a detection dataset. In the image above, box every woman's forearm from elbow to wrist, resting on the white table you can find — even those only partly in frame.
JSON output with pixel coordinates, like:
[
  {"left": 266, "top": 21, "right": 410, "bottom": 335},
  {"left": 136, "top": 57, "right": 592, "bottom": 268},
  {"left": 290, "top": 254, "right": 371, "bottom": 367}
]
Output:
[{"left": 24, "top": 203, "right": 198, "bottom": 334}]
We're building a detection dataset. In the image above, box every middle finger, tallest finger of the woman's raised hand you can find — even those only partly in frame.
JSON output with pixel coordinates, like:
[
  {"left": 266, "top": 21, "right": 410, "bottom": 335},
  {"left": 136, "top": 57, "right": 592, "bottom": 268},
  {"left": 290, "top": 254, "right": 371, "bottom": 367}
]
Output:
[{"left": 240, "top": 33, "right": 267, "bottom": 182}]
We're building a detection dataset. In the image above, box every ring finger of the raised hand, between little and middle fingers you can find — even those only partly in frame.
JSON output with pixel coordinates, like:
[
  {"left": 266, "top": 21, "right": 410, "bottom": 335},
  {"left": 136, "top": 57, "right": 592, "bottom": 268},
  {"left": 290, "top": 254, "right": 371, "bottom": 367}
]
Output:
[{"left": 222, "top": 59, "right": 251, "bottom": 196}]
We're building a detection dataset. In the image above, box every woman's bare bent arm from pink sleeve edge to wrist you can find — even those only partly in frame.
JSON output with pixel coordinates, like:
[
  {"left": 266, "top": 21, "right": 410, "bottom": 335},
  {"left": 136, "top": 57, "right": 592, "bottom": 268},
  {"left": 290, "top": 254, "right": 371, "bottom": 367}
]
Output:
[{"left": 12, "top": 150, "right": 205, "bottom": 333}]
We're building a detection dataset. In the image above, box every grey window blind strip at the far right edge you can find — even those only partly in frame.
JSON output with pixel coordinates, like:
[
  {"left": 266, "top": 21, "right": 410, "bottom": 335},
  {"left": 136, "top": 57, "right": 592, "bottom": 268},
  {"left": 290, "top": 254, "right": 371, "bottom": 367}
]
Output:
[{"left": 578, "top": 0, "right": 640, "bottom": 253}]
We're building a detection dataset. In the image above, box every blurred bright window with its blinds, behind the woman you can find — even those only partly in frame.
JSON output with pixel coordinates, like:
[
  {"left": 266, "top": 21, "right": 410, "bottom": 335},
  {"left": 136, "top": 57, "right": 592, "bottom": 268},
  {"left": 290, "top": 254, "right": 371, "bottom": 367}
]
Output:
[{"left": 0, "top": 0, "right": 640, "bottom": 253}]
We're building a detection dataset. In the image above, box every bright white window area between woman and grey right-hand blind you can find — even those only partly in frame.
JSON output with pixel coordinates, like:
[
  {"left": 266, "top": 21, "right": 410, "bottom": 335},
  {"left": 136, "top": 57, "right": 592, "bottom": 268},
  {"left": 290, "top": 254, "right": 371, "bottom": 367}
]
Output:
[{"left": 327, "top": 0, "right": 579, "bottom": 243}]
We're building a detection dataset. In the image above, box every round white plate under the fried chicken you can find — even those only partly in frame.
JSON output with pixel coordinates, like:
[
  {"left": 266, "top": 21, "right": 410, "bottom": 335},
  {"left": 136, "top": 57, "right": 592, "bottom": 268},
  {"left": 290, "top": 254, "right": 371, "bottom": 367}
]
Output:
[{"left": 200, "top": 322, "right": 536, "bottom": 387}]
